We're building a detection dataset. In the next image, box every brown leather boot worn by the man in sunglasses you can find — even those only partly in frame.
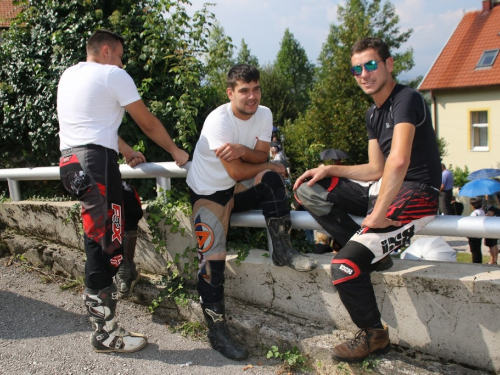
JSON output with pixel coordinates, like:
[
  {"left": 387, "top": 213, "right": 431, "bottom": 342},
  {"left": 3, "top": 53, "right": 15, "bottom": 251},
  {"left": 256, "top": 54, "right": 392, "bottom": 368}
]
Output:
[{"left": 333, "top": 325, "right": 391, "bottom": 363}]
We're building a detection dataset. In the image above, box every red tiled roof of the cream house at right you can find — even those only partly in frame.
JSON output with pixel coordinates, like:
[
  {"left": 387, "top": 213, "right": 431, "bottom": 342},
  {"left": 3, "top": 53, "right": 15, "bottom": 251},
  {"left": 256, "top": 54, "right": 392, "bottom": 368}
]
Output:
[{"left": 419, "top": 6, "right": 500, "bottom": 91}]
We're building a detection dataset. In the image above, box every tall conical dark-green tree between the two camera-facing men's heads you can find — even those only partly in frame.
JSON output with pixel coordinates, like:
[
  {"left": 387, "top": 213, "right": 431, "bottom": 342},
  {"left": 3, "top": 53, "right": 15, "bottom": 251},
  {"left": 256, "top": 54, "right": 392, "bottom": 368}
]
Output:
[{"left": 275, "top": 29, "right": 314, "bottom": 114}]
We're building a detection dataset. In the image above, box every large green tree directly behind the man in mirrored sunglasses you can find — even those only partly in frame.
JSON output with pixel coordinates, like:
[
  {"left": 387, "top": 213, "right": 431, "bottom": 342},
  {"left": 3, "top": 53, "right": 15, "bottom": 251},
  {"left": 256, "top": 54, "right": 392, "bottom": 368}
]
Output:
[{"left": 285, "top": 0, "right": 413, "bottom": 170}]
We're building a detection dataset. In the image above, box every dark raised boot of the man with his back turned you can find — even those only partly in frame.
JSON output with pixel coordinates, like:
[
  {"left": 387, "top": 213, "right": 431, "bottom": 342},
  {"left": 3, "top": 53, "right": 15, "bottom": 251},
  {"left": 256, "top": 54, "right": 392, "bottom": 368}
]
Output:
[{"left": 115, "top": 231, "right": 140, "bottom": 298}]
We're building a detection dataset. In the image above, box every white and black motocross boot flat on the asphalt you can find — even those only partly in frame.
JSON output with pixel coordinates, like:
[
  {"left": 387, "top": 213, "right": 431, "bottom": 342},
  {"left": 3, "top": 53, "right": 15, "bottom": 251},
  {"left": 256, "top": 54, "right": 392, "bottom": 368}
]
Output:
[{"left": 83, "top": 284, "right": 148, "bottom": 353}]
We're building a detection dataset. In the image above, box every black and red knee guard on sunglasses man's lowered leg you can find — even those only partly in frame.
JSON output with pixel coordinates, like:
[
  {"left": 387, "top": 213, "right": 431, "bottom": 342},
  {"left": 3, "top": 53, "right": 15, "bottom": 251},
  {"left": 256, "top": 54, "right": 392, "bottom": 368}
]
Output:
[{"left": 330, "top": 241, "right": 374, "bottom": 285}]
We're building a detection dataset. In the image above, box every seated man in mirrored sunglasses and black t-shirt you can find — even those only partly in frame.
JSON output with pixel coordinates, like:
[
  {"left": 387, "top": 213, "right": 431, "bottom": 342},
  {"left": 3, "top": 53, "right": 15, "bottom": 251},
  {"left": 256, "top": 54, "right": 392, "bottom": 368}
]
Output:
[{"left": 294, "top": 38, "right": 441, "bottom": 362}]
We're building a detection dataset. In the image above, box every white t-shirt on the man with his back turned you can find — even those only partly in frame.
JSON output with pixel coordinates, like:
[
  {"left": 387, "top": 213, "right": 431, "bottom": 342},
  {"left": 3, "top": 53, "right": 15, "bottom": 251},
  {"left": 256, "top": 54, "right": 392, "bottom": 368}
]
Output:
[{"left": 57, "top": 62, "right": 141, "bottom": 152}]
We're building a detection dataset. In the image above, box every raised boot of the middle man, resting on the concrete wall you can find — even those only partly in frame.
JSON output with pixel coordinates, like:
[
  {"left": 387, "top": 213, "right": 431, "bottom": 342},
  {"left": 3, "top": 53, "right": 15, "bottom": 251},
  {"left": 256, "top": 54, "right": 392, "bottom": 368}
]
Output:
[{"left": 266, "top": 215, "right": 318, "bottom": 272}]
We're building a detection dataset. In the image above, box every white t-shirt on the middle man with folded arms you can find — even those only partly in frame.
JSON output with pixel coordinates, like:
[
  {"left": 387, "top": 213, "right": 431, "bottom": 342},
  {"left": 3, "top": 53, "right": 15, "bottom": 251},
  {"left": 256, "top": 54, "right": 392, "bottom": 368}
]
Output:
[{"left": 186, "top": 103, "right": 273, "bottom": 195}]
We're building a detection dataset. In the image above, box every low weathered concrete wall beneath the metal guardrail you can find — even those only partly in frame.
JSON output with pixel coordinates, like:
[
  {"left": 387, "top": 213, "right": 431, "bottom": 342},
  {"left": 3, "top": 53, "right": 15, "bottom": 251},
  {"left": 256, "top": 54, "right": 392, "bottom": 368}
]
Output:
[{"left": 0, "top": 202, "right": 500, "bottom": 371}]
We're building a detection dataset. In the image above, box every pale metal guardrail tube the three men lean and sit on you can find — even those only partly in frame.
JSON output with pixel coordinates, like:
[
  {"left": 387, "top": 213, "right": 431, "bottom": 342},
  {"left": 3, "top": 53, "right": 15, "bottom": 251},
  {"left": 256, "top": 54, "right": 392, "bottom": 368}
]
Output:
[{"left": 0, "top": 162, "right": 500, "bottom": 238}]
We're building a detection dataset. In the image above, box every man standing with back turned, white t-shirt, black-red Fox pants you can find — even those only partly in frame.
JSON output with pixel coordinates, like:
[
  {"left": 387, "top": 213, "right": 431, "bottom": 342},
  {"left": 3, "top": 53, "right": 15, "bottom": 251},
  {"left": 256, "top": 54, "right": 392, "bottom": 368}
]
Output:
[{"left": 57, "top": 30, "right": 189, "bottom": 353}]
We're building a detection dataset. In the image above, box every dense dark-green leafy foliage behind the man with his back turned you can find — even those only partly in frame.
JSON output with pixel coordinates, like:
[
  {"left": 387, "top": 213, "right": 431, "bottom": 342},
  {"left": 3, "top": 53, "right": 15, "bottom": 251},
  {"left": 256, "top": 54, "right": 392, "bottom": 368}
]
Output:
[{"left": 0, "top": 0, "right": 213, "bottom": 197}]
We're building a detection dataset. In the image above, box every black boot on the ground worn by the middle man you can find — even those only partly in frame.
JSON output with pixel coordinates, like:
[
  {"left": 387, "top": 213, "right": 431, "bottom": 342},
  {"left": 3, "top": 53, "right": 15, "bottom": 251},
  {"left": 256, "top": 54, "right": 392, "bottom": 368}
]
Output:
[{"left": 201, "top": 301, "right": 248, "bottom": 361}]
